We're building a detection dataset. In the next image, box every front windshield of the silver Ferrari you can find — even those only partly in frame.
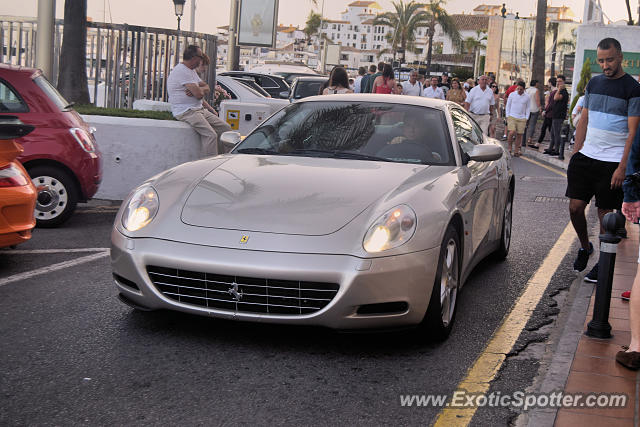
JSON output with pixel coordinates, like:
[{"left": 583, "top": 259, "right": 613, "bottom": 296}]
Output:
[{"left": 233, "top": 101, "right": 455, "bottom": 165}]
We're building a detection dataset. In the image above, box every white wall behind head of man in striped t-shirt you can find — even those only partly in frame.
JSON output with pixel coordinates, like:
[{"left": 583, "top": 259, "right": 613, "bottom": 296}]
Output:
[{"left": 571, "top": 24, "right": 640, "bottom": 99}]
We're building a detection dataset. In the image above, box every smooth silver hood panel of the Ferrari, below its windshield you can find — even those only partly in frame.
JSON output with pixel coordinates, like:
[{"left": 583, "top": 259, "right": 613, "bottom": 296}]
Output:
[{"left": 181, "top": 154, "right": 428, "bottom": 236}]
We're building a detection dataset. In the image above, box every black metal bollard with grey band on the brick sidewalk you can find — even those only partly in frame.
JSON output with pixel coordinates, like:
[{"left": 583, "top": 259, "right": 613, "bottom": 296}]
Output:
[{"left": 585, "top": 212, "right": 625, "bottom": 338}]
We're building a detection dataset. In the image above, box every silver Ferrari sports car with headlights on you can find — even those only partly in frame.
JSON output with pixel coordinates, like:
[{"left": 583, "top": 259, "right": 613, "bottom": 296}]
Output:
[{"left": 111, "top": 94, "right": 514, "bottom": 339}]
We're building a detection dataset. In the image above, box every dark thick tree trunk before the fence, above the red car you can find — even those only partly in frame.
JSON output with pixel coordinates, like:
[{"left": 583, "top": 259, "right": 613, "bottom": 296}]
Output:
[{"left": 58, "top": 0, "right": 89, "bottom": 104}]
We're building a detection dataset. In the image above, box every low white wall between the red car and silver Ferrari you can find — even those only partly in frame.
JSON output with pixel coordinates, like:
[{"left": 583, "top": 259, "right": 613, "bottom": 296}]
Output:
[{"left": 82, "top": 115, "right": 200, "bottom": 200}]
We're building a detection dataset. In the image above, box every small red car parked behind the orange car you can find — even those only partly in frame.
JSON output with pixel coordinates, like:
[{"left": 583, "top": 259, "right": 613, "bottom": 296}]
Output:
[{"left": 0, "top": 64, "right": 102, "bottom": 227}]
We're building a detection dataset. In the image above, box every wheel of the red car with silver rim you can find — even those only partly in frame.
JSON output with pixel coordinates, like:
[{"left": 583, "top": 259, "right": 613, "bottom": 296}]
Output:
[{"left": 28, "top": 166, "right": 78, "bottom": 228}]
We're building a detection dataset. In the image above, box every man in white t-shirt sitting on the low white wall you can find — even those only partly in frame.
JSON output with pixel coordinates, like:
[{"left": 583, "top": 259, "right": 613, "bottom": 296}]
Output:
[{"left": 167, "top": 45, "right": 231, "bottom": 157}]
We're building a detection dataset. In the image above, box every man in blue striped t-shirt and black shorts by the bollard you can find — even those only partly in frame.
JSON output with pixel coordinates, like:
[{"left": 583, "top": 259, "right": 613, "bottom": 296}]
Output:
[{"left": 566, "top": 38, "right": 640, "bottom": 282}]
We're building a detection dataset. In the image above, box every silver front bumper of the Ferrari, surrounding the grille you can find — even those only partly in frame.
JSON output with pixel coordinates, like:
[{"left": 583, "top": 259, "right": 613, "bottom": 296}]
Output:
[{"left": 111, "top": 229, "right": 439, "bottom": 329}]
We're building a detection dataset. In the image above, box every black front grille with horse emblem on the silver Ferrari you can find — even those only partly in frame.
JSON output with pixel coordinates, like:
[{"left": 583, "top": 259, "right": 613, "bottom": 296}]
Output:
[{"left": 147, "top": 266, "right": 340, "bottom": 315}]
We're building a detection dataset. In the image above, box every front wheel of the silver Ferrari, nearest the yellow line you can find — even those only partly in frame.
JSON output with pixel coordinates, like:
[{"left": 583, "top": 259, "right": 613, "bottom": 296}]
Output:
[{"left": 422, "top": 224, "right": 460, "bottom": 341}]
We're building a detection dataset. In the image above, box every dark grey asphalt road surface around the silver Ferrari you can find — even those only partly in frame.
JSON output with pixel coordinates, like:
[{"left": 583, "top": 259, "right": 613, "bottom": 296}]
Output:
[{"left": 0, "top": 158, "right": 575, "bottom": 425}]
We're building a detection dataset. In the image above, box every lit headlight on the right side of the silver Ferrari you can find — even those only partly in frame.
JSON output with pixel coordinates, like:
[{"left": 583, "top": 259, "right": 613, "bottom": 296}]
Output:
[{"left": 362, "top": 205, "right": 416, "bottom": 253}]
